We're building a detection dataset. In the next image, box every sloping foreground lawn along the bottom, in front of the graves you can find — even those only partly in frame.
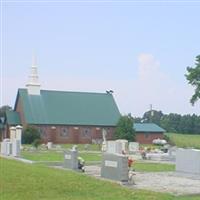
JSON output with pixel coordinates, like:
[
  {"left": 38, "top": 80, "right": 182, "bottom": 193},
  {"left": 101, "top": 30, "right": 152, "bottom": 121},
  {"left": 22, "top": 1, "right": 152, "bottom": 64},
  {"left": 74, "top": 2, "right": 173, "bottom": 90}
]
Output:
[{"left": 0, "top": 158, "right": 200, "bottom": 200}]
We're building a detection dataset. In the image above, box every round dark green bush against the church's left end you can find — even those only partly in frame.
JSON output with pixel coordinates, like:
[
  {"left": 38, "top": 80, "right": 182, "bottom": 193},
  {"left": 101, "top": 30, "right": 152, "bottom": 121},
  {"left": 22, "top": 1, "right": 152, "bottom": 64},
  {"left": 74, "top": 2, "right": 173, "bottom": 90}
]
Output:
[{"left": 22, "top": 126, "right": 41, "bottom": 144}]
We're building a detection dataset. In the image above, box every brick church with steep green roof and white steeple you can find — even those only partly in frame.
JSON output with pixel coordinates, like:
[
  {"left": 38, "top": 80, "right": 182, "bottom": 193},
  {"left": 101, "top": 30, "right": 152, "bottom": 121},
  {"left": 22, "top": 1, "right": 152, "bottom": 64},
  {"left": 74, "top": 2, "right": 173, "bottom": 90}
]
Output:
[{"left": 6, "top": 60, "right": 121, "bottom": 143}]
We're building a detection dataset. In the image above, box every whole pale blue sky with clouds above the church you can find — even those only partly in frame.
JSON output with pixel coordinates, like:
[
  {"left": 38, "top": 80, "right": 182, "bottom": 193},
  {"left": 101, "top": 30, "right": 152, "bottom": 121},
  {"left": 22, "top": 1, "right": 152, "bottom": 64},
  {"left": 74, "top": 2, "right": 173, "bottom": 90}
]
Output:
[{"left": 0, "top": 0, "right": 200, "bottom": 116}]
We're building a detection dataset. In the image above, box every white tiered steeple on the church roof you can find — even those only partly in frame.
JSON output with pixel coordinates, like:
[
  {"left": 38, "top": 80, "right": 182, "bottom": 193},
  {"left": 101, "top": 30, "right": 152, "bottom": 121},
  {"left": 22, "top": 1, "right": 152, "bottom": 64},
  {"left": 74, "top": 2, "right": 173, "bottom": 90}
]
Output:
[{"left": 26, "top": 56, "right": 40, "bottom": 95}]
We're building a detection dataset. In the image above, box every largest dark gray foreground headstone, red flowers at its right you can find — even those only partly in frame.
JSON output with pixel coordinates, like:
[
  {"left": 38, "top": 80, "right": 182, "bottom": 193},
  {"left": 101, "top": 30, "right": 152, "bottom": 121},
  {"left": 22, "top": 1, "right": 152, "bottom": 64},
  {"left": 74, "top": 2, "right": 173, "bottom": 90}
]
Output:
[{"left": 101, "top": 153, "right": 128, "bottom": 182}]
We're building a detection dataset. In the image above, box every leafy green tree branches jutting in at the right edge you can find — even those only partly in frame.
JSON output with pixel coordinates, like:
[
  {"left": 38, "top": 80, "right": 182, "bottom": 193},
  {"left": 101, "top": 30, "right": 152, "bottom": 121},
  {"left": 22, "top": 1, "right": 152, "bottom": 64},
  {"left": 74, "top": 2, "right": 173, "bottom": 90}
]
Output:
[{"left": 185, "top": 55, "right": 200, "bottom": 105}]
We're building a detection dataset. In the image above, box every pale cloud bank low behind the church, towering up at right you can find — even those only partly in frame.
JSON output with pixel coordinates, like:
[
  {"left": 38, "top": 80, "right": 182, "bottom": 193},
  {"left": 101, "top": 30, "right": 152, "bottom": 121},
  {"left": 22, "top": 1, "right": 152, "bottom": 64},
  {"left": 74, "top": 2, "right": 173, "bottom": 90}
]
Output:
[{"left": 3, "top": 53, "right": 200, "bottom": 116}]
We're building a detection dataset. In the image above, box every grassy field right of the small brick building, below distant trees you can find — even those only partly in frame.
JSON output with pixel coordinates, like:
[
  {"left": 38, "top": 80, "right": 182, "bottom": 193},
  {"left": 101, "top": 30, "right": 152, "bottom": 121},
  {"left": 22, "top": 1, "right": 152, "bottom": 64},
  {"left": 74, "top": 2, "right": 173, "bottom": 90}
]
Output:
[{"left": 166, "top": 133, "right": 200, "bottom": 149}]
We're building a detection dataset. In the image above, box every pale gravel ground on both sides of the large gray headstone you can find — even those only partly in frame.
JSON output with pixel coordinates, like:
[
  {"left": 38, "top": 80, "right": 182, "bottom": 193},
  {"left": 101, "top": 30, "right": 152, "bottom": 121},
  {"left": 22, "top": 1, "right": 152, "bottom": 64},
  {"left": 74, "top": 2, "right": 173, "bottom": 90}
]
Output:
[{"left": 86, "top": 166, "right": 200, "bottom": 195}]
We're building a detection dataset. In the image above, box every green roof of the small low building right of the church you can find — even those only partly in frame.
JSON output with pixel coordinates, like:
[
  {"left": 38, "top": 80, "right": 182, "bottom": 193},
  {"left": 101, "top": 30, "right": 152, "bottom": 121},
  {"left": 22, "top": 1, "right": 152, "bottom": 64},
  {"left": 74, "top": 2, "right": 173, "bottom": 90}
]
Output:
[{"left": 133, "top": 123, "right": 165, "bottom": 133}]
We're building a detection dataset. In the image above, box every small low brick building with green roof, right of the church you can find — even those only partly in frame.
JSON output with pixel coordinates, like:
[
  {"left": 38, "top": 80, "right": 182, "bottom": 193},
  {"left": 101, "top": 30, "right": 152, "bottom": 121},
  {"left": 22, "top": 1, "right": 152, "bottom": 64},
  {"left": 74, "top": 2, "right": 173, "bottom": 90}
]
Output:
[{"left": 134, "top": 123, "right": 165, "bottom": 144}]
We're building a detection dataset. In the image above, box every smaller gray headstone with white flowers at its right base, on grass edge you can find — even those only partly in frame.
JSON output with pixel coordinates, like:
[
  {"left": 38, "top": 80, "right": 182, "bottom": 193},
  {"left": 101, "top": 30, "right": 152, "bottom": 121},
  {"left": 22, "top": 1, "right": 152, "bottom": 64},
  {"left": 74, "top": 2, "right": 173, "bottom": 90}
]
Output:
[{"left": 63, "top": 150, "right": 78, "bottom": 170}]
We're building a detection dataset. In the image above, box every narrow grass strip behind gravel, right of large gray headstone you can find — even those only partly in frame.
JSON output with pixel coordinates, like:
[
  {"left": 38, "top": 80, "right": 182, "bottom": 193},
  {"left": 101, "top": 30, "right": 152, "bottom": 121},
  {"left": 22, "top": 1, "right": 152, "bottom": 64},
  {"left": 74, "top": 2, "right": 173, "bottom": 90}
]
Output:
[{"left": 133, "top": 161, "right": 175, "bottom": 172}]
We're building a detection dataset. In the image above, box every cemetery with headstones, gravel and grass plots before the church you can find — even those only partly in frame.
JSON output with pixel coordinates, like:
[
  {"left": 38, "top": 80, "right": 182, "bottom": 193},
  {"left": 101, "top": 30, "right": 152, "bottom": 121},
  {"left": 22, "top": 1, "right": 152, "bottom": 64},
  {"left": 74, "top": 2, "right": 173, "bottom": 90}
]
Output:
[{"left": 1, "top": 129, "right": 200, "bottom": 198}]
